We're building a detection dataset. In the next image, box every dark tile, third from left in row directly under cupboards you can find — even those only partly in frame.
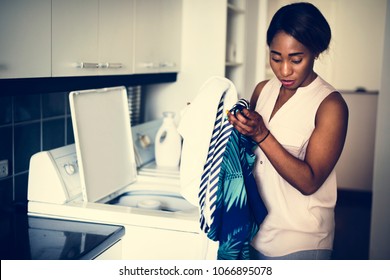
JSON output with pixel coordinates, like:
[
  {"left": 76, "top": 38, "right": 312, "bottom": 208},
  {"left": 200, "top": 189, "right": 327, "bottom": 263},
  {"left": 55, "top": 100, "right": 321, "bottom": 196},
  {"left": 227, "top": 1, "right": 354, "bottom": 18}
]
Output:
[{"left": 42, "top": 92, "right": 65, "bottom": 118}]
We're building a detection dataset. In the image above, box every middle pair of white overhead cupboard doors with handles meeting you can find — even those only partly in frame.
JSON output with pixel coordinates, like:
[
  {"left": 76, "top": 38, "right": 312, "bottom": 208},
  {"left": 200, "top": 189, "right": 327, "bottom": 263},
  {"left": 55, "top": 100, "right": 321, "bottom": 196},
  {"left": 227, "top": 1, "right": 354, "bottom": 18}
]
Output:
[{"left": 52, "top": 0, "right": 133, "bottom": 77}]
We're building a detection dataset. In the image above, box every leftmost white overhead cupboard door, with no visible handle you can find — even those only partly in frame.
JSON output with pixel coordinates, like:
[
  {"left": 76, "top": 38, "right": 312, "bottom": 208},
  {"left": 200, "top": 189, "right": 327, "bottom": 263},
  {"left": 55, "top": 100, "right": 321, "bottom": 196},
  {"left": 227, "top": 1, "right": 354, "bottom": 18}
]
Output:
[{"left": 0, "top": 0, "right": 51, "bottom": 79}]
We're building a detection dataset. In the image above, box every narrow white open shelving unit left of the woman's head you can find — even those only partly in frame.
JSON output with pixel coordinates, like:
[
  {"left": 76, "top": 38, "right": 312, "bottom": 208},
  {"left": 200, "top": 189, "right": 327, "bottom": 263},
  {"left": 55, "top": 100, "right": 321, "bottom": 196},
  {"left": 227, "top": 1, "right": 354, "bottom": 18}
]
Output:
[{"left": 225, "top": 0, "right": 246, "bottom": 95}]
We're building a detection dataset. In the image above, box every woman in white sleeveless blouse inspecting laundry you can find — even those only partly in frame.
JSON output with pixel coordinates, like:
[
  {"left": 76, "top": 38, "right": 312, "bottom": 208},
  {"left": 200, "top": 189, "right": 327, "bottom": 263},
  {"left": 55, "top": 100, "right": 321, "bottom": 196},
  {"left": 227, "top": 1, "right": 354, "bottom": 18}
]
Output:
[{"left": 228, "top": 3, "right": 348, "bottom": 259}]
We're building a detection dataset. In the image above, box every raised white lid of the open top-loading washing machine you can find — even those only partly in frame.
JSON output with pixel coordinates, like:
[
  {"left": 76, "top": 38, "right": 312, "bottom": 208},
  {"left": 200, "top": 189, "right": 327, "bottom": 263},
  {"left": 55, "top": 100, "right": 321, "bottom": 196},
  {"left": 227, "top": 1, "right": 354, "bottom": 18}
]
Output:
[{"left": 69, "top": 87, "right": 137, "bottom": 202}]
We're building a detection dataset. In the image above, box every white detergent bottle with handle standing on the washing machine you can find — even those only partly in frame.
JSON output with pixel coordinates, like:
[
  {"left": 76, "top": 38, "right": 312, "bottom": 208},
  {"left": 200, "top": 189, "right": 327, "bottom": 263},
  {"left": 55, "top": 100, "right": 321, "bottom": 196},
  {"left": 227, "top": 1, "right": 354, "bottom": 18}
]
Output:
[{"left": 155, "top": 112, "right": 182, "bottom": 167}]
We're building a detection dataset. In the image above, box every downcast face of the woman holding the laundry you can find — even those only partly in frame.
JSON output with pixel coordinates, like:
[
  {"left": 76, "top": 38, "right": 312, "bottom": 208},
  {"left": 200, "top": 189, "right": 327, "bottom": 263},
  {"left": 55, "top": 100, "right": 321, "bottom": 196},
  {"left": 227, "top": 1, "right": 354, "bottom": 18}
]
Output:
[{"left": 270, "top": 32, "right": 317, "bottom": 91}]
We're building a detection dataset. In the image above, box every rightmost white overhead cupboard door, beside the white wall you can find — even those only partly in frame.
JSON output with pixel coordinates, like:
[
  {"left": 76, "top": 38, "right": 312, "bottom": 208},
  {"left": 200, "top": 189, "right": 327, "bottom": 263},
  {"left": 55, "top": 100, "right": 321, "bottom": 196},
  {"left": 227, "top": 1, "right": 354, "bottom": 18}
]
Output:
[{"left": 134, "top": 0, "right": 182, "bottom": 73}]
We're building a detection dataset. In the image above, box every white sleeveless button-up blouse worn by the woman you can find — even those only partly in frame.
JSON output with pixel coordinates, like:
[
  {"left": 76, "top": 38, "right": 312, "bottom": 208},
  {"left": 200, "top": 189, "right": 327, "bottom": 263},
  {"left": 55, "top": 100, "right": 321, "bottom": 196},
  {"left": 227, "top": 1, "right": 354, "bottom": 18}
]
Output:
[{"left": 252, "top": 76, "right": 337, "bottom": 257}]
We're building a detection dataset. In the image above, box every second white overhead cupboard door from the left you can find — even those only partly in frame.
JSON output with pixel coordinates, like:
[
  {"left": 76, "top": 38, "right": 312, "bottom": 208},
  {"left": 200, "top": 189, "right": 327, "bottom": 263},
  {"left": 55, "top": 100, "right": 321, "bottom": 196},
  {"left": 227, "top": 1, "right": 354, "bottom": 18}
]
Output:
[{"left": 52, "top": 0, "right": 99, "bottom": 76}]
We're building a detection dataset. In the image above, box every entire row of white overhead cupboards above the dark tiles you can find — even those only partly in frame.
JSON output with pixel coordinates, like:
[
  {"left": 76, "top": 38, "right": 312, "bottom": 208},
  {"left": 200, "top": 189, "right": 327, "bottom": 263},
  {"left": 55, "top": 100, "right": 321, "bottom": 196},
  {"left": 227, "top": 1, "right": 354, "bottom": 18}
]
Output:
[{"left": 0, "top": 0, "right": 182, "bottom": 79}]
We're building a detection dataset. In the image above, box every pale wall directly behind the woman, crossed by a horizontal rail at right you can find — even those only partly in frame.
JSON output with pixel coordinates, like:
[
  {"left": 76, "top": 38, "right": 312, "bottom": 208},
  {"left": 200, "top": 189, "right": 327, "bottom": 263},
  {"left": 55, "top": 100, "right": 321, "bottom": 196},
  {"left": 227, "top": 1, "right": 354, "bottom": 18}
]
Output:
[{"left": 267, "top": 0, "right": 387, "bottom": 191}]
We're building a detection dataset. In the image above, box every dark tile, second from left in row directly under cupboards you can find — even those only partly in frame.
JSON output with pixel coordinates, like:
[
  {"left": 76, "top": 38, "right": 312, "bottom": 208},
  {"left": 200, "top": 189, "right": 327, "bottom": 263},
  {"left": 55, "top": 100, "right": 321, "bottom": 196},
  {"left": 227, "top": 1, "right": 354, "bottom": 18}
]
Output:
[{"left": 14, "top": 94, "right": 41, "bottom": 122}]
